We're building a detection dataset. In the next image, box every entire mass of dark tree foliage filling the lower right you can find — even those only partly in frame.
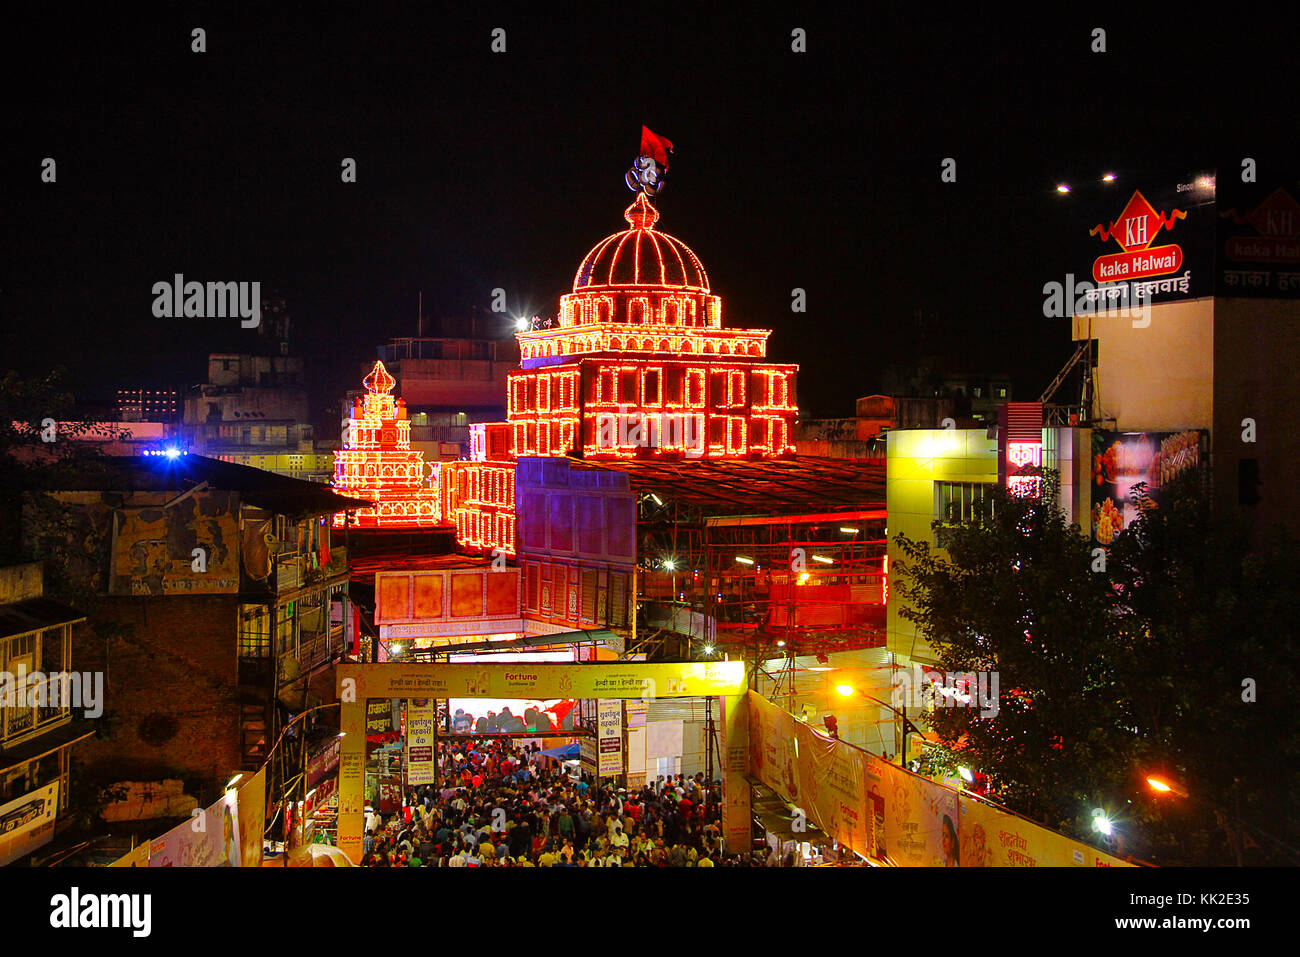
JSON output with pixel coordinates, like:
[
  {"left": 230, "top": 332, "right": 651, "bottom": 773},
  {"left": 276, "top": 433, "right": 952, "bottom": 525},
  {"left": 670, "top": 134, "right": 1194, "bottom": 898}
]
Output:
[{"left": 893, "top": 475, "right": 1300, "bottom": 863}]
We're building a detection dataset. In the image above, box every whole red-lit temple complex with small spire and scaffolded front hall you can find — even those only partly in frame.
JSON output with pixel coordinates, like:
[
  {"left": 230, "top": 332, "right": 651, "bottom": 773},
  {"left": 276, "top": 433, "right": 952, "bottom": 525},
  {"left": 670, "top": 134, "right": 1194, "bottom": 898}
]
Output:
[{"left": 353, "top": 179, "right": 887, "bottom": 655}]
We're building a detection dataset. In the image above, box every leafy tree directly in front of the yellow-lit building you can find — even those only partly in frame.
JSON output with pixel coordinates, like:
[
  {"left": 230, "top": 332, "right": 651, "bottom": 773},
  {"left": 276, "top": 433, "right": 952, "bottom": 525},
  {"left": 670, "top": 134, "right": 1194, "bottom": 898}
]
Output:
[{"left": 894, "top": 473, "right": 1132, "bottom": 836}]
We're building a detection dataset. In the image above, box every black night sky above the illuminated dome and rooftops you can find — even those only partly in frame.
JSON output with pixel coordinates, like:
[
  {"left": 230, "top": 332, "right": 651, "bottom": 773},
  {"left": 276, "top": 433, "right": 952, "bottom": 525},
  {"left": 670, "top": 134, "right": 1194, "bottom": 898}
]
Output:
[{"left": 0, "top": 4, "right": 1297, "bottom": 417}]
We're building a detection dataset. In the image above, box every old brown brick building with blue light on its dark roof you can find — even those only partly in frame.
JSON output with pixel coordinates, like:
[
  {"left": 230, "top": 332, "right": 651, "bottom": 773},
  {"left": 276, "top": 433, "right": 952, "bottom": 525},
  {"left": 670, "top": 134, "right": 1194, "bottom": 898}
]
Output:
[{"left": 39, "top": 454, "right": 364, "bottom": 804}]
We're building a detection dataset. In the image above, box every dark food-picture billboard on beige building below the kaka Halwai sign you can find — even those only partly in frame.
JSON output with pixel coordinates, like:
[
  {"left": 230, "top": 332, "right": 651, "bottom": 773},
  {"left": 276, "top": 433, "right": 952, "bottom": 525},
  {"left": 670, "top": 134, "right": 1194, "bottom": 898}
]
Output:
[{"left": 1092, "top": 429, "right": 1209, "bottom": 545}]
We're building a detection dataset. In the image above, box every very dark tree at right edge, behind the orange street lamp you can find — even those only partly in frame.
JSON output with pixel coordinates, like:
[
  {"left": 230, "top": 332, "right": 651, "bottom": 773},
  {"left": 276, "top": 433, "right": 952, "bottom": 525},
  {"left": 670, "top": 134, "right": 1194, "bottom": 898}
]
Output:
[{"left": 1110, "top": 473, "right": 1300, "bottom": 865}]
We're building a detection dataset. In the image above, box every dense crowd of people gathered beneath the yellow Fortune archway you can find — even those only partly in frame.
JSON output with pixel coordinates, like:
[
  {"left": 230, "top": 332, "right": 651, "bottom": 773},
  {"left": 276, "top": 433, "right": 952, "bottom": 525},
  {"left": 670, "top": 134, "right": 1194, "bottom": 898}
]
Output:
[{"left": 361, "top": 739, "right": 774, "bottom": 867}]
